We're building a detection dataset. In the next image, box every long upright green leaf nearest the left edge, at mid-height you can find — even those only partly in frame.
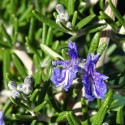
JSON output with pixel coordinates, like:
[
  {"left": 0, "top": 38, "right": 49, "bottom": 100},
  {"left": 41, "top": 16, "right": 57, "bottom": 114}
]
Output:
[{"left": 3, "top": 49, "right": 11, "bottom": 89}]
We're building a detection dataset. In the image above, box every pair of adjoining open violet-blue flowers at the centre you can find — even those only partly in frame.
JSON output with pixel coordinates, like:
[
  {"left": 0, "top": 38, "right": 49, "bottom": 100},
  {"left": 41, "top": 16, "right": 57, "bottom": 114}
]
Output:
[{"left": 50, "top": 41, "right": 108, "bottom": 100}]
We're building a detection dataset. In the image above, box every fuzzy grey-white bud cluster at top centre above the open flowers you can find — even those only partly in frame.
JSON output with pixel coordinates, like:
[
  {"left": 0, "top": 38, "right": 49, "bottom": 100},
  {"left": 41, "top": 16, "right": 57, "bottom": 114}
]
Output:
[{"left": 56, "top": 4, "right": 72, "bottom": 29}]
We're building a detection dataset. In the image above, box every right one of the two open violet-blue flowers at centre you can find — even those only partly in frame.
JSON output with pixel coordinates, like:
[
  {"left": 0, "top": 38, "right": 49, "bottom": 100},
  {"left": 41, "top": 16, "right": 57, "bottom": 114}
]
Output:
[{"left": 82, "top": 53, "right": 108, "bottom": 101}]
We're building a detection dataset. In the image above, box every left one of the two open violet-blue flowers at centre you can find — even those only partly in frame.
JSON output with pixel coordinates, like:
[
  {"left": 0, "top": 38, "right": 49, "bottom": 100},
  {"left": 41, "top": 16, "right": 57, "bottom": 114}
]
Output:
[{"left": 50, "top": 41, "right": 80, "bottom": 91}]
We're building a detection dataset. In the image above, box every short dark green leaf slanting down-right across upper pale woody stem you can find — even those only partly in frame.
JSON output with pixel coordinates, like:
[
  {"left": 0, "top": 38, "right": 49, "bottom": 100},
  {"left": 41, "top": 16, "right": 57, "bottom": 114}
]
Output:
[{"left": 100, "top": 11, "right": 118, "bottom": 32}]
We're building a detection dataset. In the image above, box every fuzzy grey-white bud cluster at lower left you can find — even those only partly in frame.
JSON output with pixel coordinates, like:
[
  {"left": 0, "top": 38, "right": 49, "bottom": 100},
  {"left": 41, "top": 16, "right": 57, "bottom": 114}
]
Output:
[{"left": 8, "top": 76, "right": 34, "bottom": 99}]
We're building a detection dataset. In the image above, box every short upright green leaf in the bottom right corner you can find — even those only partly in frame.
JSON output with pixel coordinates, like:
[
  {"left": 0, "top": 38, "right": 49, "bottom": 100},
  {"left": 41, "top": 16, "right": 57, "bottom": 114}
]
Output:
[{"left": 116, "top": 106, "right": 124, "bottom": 125}]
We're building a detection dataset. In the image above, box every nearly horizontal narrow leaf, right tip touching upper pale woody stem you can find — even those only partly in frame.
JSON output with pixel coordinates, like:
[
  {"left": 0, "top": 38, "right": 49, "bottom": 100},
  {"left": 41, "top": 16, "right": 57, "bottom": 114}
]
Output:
[{"left": 82, "top": 24, "right": 107, "bottom": 34}]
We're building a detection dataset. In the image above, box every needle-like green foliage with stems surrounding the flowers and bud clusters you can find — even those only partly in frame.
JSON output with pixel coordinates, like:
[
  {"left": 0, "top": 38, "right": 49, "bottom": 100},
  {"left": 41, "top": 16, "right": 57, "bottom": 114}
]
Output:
[{"left": 0, "top": 0, "right": 125, "bottom": 125}]
